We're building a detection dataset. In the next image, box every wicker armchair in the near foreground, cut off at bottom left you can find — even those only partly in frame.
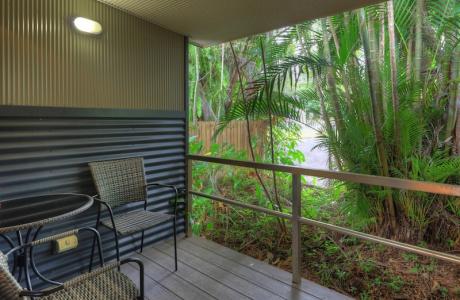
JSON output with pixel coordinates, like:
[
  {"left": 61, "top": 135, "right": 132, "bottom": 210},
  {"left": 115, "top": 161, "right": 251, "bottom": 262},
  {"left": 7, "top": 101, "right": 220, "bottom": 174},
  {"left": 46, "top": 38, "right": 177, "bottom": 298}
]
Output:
[{"left": 0, "top": 228, "right": 144, "bottom": 300}]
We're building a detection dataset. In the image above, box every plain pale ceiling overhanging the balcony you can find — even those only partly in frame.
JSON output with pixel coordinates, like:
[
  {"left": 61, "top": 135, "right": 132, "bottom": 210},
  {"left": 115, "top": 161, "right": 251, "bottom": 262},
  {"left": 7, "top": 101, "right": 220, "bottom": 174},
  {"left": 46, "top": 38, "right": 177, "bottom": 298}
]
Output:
[{"left": 99, "top": 0, "right": 382, "bottom": 46}]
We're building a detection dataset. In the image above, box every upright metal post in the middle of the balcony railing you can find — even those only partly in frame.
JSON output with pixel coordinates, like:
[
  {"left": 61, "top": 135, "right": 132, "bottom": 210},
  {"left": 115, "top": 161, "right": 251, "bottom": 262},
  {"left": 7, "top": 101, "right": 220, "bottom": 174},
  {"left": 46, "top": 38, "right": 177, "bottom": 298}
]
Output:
[{"left": 292, "top": 174, "right": 302, "bottom": 284}]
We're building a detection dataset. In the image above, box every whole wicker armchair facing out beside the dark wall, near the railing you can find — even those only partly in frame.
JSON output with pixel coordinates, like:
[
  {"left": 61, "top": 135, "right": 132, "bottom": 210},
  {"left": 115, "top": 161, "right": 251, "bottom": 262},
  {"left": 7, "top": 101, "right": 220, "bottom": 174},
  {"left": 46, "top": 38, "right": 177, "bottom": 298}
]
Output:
[{"left": 89, "top": 157, "right": 182, "bottom": 271}]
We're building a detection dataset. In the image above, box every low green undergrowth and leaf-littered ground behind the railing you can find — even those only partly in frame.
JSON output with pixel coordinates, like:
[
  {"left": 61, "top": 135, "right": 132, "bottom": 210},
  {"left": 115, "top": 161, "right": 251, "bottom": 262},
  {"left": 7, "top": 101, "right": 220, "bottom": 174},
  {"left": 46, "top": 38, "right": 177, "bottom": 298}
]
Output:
[{"left": 191, "top": 129, "right": 460, "bottom": 299}]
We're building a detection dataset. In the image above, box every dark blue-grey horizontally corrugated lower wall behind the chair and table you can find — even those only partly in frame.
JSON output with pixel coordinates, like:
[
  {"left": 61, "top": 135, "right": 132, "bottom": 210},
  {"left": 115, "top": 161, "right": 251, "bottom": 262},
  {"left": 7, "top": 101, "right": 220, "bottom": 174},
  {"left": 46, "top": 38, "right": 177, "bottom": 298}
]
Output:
[{"left": 0, "top": 107, "right": 186, "bottom": 288}]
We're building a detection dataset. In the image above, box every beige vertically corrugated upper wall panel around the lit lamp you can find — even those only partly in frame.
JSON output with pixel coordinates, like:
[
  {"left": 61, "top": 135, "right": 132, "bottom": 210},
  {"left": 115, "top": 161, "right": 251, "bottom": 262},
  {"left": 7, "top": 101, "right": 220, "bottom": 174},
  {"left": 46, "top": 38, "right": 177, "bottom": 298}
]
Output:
[{"left": 0, "top": 0, "right": 184, "bottom": 111}]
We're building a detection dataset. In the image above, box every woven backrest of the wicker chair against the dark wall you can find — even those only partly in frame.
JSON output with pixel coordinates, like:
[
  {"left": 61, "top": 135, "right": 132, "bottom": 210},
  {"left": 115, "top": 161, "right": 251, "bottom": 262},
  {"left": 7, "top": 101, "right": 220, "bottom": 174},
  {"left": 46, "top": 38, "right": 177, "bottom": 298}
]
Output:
[{"left": 89, "top": 157, "right": 147, "bottom": 207}]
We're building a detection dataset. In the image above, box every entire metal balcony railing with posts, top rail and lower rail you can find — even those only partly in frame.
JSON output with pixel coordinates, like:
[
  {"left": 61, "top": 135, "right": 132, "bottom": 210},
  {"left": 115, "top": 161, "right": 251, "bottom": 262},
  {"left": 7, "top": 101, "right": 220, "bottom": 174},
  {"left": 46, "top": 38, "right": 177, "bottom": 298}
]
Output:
[{"left": 187, "top": 155, "right": 460, "bottom": 284}]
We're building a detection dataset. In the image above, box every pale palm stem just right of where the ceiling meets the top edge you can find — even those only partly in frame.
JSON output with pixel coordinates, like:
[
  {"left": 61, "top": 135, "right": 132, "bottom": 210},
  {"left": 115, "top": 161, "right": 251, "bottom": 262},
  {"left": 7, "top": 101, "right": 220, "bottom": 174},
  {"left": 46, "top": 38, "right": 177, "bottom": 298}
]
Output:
[{"left": 387, "top": 0, "right": 401, "bottom": 165}]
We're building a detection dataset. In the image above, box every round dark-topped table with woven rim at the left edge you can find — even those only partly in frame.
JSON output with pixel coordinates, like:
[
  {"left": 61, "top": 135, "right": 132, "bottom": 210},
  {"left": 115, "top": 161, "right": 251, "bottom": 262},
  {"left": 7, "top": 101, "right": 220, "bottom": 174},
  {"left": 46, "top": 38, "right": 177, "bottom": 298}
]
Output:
[{"left": 0, "top": 193, "right": 93, "bottom": 290}]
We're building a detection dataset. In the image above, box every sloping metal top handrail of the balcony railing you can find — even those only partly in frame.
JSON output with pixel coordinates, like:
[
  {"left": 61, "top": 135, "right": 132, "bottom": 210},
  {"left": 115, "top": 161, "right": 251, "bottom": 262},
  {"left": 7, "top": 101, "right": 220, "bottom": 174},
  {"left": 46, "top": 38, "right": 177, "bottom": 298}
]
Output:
[{"left": 187, "top": 155, "right": 460, "bottom": 197}]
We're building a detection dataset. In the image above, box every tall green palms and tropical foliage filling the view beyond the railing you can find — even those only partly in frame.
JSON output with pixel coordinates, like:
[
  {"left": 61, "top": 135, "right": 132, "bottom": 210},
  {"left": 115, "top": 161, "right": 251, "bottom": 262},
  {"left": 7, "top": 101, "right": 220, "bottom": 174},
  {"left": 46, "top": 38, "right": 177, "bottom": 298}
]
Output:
[{"left": 189, "top": 0, "right": 460, "bottom": 295}]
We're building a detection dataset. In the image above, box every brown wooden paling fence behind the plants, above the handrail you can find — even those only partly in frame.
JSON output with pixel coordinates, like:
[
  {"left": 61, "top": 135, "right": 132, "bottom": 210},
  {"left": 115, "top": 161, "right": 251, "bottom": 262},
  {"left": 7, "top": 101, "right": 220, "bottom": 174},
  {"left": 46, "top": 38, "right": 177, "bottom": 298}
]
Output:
[{"left": 190, "top": 121, "right": 268, "bottom": 158}]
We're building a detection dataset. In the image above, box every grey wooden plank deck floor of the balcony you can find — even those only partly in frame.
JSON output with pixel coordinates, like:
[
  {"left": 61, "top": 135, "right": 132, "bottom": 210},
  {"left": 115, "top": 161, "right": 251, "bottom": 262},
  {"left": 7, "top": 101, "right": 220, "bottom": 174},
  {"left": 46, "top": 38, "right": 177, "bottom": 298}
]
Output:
[{"left": 123, "top": 237, "right": 349, "bottom": 300}]
